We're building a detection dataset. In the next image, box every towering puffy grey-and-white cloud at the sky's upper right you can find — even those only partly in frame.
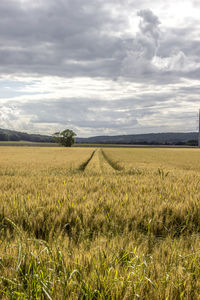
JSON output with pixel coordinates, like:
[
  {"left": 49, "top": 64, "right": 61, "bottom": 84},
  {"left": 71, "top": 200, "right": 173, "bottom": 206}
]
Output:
[{"left": 122, "top": 9, "right": 200, "bottom": 84}]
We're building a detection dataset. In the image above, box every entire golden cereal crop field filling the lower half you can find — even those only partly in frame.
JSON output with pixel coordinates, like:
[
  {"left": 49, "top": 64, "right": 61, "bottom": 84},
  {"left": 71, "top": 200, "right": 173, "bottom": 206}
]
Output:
[{"left": 0, "top": 146, "right": 200, "bottom": 300}]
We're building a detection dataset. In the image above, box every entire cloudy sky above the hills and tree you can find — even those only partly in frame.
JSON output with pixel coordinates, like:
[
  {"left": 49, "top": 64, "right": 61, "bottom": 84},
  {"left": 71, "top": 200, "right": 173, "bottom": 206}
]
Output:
[{"left": 0, "top": 0, "right": 200, "bottom": 137}]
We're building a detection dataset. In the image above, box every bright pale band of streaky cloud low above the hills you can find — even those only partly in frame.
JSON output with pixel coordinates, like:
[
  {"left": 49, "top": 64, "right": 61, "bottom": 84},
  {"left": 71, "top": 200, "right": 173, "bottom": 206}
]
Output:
[{"left": 0, "top": 78, "right": 199, "bottom": 136}]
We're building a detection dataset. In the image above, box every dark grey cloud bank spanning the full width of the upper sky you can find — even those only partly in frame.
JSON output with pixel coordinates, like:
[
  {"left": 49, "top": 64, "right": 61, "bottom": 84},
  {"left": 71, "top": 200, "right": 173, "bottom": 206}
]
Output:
[{"left": 0, "top": 0, "right": 200, "bottom": 83}]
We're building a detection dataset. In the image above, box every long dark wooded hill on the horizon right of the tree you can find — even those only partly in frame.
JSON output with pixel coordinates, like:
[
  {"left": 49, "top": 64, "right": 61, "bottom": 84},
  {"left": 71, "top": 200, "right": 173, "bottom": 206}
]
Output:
[{"left": 76, "top": 132, "right": 198, "bottom": 146}]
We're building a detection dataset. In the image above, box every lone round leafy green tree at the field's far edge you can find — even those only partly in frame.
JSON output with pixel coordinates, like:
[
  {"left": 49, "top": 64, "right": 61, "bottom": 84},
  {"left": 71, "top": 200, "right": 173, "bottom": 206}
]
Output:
[{"left": 53, "top": 129, "right": 76, "bottom": 147}]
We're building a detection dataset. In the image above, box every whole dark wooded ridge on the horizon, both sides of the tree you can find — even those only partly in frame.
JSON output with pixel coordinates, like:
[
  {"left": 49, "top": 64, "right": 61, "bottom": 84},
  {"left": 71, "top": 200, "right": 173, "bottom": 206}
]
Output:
[{"left": 0, "top": 128, "right": 198, "bottom": 146}]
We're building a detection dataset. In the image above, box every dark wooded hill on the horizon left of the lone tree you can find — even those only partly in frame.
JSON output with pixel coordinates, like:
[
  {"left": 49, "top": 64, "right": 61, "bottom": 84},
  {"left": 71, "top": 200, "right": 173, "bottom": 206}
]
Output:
[{"left": 0, "top": 128, "right": 55, "bottom": 143}]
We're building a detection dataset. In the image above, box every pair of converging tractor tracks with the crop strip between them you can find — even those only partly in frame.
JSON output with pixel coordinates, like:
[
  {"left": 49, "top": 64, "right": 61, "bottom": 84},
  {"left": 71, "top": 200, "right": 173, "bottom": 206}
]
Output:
[{"left": 78, "top": 148, "right": 123, "bottom": 173}]
